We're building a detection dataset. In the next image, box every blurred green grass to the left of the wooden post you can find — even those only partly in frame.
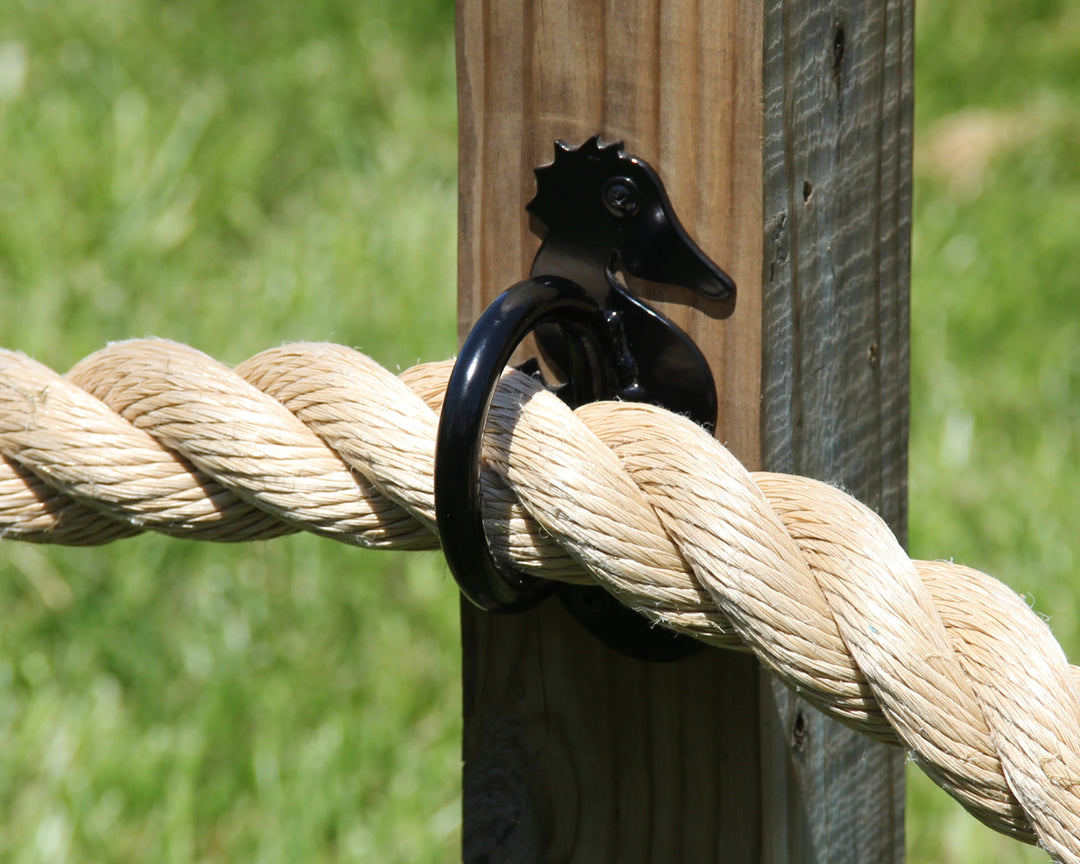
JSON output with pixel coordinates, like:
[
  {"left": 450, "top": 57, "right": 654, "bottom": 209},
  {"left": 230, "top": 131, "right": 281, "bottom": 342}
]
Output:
[{"left": 0, "top": 0, "right": 461, "bottom": 863}]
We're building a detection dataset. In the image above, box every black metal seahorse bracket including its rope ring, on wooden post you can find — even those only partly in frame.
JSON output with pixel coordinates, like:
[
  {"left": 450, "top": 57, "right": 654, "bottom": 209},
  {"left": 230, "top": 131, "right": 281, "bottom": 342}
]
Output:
[{"left": 435, "top": 135, "right": 735, "bottom": 660}]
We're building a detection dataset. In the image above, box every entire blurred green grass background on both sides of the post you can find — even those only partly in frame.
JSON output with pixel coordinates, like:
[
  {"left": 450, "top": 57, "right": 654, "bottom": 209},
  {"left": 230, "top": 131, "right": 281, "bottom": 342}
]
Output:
[{"left": 0, "top": 0, "right": 1080, "bottom": 864}]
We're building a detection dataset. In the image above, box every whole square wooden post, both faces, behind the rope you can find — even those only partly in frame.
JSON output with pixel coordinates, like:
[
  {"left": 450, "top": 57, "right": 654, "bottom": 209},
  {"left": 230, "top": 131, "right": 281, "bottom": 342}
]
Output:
[{"left": 458, "top": 0, "right": 913, "bottom": 864}]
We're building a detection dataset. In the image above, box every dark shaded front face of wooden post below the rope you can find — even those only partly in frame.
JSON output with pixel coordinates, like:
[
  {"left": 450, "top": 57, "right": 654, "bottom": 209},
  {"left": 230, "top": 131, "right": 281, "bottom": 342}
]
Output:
[{"left": 463, "top": 602, "right": 761, "bottom": 864}]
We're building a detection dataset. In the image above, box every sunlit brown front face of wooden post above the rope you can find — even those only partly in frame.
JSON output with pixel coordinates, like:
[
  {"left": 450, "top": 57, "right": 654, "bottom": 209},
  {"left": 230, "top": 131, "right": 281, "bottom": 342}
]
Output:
[{"left": 458, "top": 0, "right": 762, "bottom": 465}]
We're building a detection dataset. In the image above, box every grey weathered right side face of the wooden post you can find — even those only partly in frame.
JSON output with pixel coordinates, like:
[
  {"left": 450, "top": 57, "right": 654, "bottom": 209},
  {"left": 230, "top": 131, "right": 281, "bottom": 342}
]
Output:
[{"left": 761, "top": 0, "right": 913, "bottom": 862}]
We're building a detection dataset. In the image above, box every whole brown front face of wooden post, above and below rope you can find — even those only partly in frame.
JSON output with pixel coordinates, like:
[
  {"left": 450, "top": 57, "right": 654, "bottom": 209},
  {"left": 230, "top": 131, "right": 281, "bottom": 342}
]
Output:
[{"left": 458, "top": 0, "right": 761, "bottom": 863}]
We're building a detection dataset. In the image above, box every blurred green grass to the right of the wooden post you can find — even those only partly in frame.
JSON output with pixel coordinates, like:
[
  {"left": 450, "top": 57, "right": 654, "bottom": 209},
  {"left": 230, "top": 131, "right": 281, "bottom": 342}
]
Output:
[{"left": 907, "top": 0, "right": 1080, "bottom": 864}]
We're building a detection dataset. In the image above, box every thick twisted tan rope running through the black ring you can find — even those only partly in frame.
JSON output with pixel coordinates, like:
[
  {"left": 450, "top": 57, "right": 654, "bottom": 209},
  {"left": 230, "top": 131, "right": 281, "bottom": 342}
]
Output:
[{"left": 0, "top": 340, "right": 1080, "bottom": 863}]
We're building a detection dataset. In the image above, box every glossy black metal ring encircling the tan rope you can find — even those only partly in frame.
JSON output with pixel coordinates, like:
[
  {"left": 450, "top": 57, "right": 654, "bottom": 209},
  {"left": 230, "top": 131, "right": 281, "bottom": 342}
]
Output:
[{"left": 435, "top": 276, "right": 615, "bottom": 612}]
